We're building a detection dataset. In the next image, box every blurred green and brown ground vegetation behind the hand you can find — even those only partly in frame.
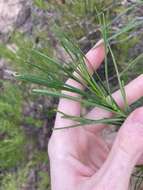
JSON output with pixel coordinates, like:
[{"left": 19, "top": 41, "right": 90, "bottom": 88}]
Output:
[{"left": 0, "top": 0, "right": 143, "bottom": 190}]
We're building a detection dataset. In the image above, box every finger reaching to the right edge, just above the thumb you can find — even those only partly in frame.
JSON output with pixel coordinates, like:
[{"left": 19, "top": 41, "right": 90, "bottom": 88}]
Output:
[{"left": 86, "top": 75, "right": 143, "bottom": 132}]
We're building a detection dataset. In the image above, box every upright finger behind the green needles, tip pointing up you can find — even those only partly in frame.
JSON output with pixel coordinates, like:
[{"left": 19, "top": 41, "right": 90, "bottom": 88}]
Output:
[{"left": 55, "top": 41, "right": 105, "bottom": 127}]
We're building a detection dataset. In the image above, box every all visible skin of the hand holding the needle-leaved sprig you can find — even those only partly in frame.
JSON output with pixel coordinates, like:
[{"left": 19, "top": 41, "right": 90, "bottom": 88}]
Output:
[{"left": 48, "top": 41, "right": 143, "bottom": 190}]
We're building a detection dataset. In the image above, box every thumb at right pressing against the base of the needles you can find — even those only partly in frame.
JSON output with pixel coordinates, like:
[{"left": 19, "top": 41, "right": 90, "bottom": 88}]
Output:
[{"left": 94, "top": 107, "right": 143, "bottom": 190}]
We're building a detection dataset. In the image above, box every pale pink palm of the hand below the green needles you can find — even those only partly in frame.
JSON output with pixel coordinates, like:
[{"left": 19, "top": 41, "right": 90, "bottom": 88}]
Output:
[{"left": 49, "top": 104, "right": 113, "bottom": 190}]
